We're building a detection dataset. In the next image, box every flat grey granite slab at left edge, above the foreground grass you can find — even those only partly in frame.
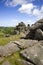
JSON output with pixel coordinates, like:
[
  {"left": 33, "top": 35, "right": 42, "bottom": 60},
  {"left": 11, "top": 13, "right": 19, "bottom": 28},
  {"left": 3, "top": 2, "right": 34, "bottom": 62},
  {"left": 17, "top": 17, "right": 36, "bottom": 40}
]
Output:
[{"left": 0, "top": 42, "right": 19, "bottom": 57}]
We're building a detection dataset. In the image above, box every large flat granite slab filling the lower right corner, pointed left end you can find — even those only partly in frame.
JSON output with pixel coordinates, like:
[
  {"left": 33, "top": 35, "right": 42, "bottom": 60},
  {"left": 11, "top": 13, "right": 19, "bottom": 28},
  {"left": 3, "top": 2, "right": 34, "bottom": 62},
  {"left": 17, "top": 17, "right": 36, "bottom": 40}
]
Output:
[{"left": 20, "top": 44, "right": 43, "bottom": 65}]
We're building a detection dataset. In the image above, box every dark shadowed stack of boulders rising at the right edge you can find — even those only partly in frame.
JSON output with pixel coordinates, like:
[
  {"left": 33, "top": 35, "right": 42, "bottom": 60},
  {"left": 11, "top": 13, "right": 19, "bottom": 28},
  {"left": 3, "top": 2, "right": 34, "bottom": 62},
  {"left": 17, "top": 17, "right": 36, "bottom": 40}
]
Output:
[{"left": 25, "top": 19, "right": 43, "bottom": 40}]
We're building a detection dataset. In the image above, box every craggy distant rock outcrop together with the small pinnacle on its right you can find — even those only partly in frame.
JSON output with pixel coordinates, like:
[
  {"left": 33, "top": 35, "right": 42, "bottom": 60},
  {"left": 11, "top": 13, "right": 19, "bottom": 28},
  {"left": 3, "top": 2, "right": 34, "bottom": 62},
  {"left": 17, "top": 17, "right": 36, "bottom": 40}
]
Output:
[{"left": 14, "top": 22, "right": 30, "bottom": 34}]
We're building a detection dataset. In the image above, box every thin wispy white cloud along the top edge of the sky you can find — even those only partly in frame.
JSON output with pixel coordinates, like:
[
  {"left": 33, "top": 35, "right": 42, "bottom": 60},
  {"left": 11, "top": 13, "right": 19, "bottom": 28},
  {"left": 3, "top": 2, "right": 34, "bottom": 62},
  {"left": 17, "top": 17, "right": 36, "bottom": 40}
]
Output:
[{"left": 3, "top": 0, "right": 35, "bottom": 6}]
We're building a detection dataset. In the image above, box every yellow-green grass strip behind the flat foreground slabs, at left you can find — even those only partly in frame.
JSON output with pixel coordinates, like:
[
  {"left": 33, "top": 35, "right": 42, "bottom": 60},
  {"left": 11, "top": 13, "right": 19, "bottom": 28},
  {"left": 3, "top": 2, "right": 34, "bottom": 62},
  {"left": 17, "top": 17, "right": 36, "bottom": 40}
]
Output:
[{"left": 0, "top": 35, "right": 22, "bottom": 45}]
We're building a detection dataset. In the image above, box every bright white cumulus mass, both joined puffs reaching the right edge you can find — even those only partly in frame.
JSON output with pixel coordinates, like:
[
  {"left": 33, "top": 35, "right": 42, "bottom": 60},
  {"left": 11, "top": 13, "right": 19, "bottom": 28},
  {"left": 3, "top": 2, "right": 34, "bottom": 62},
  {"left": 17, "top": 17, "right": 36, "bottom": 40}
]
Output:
[{"left": 18, "top": 3, "right": 43, "bottom": 19}]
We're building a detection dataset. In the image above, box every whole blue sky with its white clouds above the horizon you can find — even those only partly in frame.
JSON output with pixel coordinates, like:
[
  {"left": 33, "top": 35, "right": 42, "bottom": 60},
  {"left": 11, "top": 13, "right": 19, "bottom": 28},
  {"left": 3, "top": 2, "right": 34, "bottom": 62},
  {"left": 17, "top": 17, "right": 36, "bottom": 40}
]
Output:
[{"left": 0, "top": 0, "right": 43, "bottom": 26}]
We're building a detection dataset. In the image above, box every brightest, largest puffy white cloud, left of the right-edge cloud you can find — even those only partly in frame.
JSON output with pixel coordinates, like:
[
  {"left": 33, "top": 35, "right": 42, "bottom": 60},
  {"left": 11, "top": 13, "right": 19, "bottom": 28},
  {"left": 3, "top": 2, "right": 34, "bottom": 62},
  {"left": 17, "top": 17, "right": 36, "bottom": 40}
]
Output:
[{"left": 18, "top": 3, "right": 36, "bottom": 14}]
